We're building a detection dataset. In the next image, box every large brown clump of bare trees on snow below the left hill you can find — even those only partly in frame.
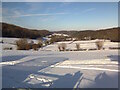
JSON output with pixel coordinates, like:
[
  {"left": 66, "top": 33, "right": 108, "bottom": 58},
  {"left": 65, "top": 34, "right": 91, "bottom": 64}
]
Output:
[{"left": 16, "top": 39, "right": 43, "bottom": 50}]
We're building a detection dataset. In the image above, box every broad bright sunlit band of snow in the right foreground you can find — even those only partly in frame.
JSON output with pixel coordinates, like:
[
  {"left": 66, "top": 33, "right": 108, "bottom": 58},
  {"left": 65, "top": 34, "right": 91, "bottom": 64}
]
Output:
[{"left": 51, "top": 59, "right": 119, "bottom": 72}]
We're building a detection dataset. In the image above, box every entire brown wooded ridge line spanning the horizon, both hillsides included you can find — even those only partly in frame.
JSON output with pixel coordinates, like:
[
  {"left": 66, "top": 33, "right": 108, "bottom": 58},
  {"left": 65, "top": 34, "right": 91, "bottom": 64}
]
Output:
[{"left": 2, "top": 23, "right": 120, "bottom": 42}]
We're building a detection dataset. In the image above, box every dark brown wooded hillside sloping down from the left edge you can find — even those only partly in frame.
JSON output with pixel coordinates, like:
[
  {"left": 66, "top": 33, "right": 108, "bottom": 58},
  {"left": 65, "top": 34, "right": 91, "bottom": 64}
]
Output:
[{"left": 2, "top": 23, "right": 51, "bottom": 39}]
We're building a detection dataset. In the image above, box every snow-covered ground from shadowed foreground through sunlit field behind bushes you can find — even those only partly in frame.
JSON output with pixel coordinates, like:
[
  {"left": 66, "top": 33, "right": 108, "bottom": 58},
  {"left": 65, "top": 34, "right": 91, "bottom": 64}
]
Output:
[{"left": 0, "top": 37, "right": 119, "bottom": 88}]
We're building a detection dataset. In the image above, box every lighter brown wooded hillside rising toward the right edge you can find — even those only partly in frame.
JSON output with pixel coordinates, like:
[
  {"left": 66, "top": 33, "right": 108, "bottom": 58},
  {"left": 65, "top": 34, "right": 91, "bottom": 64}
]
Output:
[{"left": 56, "top": 27, "right": 120, "bottom": 42}]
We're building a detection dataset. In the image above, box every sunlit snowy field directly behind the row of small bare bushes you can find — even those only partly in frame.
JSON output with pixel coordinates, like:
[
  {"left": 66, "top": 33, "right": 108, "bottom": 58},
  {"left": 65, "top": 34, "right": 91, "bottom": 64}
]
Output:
[{"left": 43, "top": 40, "right": 119, "bottom": 51}]
